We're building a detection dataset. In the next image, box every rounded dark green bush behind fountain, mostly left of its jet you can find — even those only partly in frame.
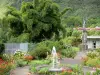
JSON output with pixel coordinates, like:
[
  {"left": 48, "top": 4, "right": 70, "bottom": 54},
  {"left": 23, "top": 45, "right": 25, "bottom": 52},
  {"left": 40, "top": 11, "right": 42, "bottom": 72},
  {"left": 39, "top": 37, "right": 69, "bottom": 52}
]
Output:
[{"left": 30, "top": 40, "right": 63, "bottom": 58}]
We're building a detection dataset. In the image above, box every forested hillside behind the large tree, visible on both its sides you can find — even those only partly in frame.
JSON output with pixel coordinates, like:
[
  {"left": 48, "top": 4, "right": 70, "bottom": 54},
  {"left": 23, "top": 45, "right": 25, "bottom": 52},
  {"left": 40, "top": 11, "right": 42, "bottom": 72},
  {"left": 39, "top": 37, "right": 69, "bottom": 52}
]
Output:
[{"left": 0, "top": 0, "right": 100, "bottom": 17}]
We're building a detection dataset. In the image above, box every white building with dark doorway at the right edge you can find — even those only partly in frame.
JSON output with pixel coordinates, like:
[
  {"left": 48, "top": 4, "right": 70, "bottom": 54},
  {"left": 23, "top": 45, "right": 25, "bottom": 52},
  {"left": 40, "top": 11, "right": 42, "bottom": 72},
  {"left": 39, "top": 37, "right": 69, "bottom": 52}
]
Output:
[{"left": 87, "top": 36, "right": 100, "bottom": 49}]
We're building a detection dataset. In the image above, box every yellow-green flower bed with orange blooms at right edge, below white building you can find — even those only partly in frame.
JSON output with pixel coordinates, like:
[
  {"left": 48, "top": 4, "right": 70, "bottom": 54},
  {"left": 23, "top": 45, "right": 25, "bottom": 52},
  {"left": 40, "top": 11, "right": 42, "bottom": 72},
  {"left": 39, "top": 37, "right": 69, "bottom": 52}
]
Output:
[{"left": 82, "top": 51, "right": 100, "bottom": 68}]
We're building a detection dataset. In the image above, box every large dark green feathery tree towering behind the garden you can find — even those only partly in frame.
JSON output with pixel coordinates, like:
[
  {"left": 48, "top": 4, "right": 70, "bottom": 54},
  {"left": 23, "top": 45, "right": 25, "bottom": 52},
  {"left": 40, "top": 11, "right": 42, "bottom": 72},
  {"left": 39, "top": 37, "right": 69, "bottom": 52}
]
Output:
[{"left": 3, "top": 0, "right": 67, "bottom": 42}]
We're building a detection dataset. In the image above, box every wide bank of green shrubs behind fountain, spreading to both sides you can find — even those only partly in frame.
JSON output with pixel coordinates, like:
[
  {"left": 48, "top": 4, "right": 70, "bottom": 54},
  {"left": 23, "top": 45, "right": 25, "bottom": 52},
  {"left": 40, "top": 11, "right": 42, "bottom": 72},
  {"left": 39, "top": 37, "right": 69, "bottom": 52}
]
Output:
[{"left": 30, "top": 39, "right": 79, "bottom": 58}]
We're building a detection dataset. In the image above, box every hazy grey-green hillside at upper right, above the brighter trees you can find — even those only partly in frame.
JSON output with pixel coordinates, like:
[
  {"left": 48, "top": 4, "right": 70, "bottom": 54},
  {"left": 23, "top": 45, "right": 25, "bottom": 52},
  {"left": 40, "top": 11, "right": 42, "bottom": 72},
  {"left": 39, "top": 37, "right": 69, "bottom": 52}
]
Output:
[{"left": 54, "top": 0, "right": 100, "bottom": 17}]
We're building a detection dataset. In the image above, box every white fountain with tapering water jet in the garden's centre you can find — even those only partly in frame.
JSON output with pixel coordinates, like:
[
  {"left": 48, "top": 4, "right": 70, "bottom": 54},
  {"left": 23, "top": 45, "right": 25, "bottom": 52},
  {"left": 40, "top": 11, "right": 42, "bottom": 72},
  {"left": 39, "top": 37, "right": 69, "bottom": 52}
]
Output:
[{"left": 49, "top": 46, "right": 62, "bottom": 72}]
